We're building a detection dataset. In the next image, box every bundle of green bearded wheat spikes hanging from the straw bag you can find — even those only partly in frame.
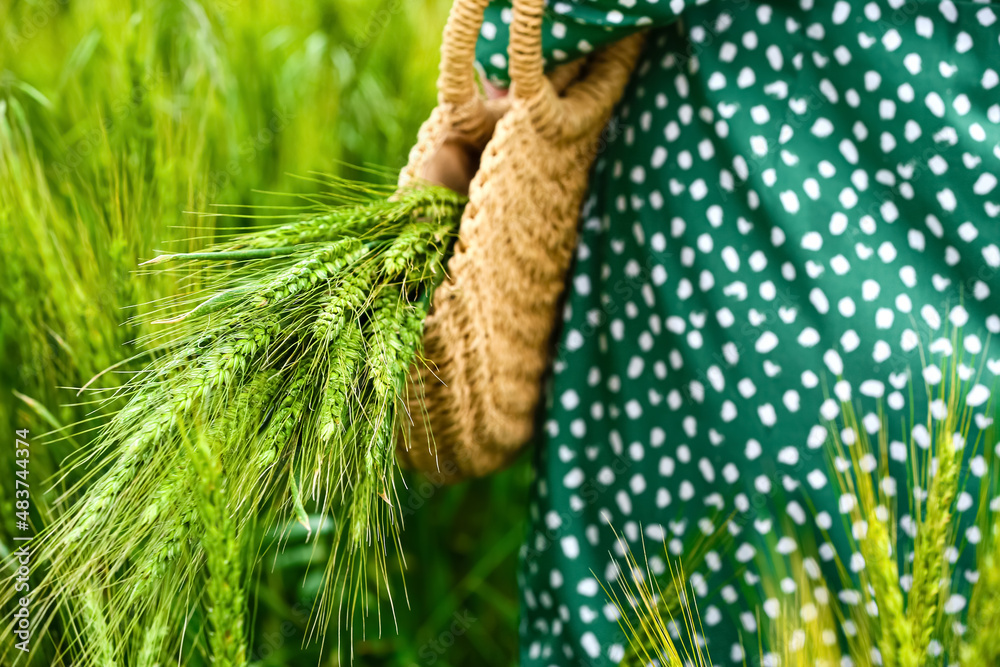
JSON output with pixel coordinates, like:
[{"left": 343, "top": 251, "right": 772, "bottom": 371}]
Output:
[{"left": 18, "top": 175, "right": 464, "bottom": 664}]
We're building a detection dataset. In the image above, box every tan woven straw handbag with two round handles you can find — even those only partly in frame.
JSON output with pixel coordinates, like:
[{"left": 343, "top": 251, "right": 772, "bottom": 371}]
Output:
[{"left": 398, "top": 0, "right": 642, "bottom": 482}]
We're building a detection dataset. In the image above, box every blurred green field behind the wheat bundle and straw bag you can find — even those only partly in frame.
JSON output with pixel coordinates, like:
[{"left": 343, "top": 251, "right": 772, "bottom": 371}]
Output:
[{"left": 0, "top": 0, "right": 530, "bottom": 666}]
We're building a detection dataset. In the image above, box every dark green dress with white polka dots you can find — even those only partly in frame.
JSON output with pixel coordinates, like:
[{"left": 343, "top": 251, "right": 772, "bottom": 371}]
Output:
[{"left": 479, "top": 0, "right": 1000, "bottom": 667}]
